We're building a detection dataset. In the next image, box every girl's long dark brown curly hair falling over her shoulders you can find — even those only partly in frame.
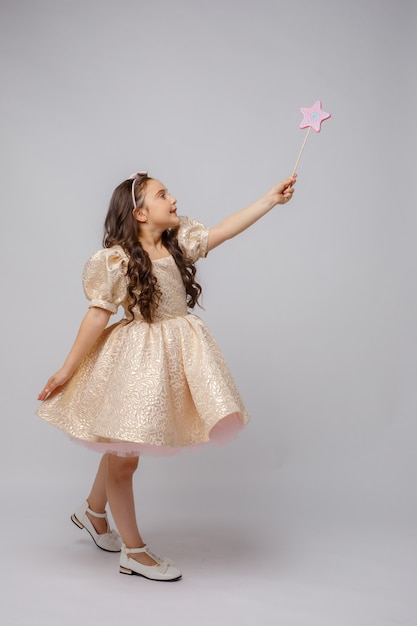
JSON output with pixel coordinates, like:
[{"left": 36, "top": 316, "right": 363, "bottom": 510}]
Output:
[{"left": 103, "top": 176, "right": 202, "bottom": 323}]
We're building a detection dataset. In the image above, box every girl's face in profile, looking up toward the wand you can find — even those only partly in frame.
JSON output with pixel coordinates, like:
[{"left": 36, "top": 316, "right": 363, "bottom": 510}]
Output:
[{"left": 136, "top": 179, "right": 180, "bottom": 231}]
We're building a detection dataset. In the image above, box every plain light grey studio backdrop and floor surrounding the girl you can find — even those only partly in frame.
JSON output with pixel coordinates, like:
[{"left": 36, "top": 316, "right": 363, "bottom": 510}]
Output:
[{"left": 0, "top": 0, "right": 417, "bottom": 626}]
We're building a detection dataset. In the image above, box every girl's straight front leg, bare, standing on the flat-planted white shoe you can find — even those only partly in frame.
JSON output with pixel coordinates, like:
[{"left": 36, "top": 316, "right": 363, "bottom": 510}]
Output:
[{"left": 105, "top": 454, "right": 156, "bottom": 565}]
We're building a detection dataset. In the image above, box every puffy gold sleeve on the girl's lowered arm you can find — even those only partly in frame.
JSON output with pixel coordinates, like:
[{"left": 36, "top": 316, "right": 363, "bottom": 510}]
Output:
[{"left": 83, "top": 246, "right": 128, "bottom": 313}]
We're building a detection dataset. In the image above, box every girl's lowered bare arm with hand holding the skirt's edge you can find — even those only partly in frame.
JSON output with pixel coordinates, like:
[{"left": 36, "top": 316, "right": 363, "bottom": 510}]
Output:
[{"left": 38, "top": 307, "right": 111, "bottom": 400}]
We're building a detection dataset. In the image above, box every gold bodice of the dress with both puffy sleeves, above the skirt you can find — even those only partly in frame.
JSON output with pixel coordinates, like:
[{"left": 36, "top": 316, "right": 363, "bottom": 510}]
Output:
[{"left": 83, "top": 216, "right": 209, "bottom": 321}]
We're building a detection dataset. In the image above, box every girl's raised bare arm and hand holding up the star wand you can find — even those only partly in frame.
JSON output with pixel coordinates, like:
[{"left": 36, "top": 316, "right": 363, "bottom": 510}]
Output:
[{"left": 208, "top": 174, "right": 297, "bottom": 250}]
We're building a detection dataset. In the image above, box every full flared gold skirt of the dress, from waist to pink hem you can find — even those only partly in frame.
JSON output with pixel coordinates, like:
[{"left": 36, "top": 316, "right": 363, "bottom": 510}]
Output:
[{"left": 37, "top": 314, "right": 249, "bottom": 455}]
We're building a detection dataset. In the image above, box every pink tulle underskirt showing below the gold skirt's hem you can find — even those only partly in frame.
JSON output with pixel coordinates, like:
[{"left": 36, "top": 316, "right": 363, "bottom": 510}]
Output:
[{"left": 70, "top": 413, "right": 244, "bottom": 456}]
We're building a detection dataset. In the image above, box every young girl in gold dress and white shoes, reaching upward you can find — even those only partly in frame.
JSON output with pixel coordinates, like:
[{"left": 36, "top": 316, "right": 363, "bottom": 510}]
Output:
[{"left": 37, "top": 172, "right": 296, "bottom": 581}]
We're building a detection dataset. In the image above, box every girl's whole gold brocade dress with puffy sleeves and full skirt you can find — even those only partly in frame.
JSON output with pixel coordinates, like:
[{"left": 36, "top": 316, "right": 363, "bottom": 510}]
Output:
[{"left": 37, "top": 217, "right": 249, "bottom": 455}]
